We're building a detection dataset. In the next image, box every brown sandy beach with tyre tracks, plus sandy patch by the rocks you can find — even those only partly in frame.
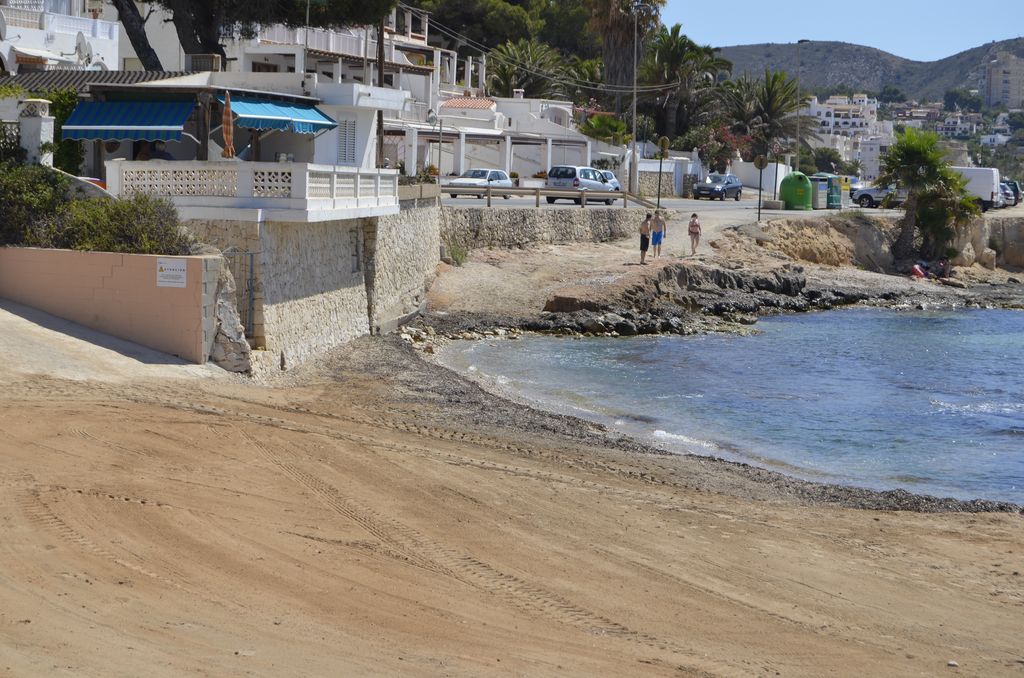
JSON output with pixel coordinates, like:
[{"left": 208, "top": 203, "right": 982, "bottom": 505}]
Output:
[{"left": 0, "top": 210, "right": 1024, "bottom": 677}]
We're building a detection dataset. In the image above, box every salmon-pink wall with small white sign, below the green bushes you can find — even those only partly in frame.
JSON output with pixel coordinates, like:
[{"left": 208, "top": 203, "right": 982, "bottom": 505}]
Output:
[{"left": 0, "top": 248, "right": 221, "bottom": 364}]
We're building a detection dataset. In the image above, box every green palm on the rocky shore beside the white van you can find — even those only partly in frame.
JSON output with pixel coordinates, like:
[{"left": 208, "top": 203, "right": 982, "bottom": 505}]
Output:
[{"left": 876, "top": 127, "right": 977, "bottom": 261}]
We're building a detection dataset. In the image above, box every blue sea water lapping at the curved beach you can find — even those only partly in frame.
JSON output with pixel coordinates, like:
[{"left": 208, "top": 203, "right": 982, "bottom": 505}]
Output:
[{"left": 441, "top": 309, "right": 1024, "bottom": 503}]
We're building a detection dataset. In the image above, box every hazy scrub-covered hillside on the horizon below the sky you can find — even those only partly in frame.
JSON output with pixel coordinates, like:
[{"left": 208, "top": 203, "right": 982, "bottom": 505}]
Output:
[{"left": 722, "top": 38, "right": 1024, "bottom": 100}]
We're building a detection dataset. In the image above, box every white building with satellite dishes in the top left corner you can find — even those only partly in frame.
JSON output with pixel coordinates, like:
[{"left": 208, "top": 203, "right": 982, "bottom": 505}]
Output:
[{"left": 0, "top": 0, "right": 119, "bottom": 74}]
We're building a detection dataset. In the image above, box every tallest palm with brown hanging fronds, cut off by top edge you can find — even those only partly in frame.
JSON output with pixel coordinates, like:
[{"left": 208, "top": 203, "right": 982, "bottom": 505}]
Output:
[{"left": 584, "top": 0, "right": 666, "bottom": 115}]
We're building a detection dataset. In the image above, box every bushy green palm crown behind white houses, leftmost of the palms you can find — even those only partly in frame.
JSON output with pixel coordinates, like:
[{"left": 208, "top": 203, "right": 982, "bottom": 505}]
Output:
[{"left": 487, "top": 39, "right": 567, "bottom": 98}]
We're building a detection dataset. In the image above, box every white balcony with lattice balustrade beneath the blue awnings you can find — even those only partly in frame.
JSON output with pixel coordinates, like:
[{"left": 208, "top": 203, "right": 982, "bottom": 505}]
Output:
[{"left": 106, "top": 160, "right": 398, "bottom": 222}]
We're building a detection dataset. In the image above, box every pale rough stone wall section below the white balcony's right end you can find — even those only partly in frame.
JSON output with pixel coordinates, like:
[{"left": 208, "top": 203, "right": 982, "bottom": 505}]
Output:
[{"left": 364, "top": 199, "right": 441, "bottom": 333}]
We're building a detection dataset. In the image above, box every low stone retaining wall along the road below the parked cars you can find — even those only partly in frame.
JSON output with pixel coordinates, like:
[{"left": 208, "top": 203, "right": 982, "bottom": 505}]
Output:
[{"left": 440, "top": 207, "right": 648, "bottom": 249}]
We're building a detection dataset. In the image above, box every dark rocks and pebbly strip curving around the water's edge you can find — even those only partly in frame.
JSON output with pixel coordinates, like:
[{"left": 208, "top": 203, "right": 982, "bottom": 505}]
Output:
[{"left": 389, "top": 223, "right": 1024, "bottom": 513}]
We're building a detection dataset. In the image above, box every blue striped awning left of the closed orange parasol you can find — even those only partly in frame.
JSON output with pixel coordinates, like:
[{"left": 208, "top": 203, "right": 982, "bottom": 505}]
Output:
[{"left": 62, "top": 101, "right": 196, "bottom": 141}]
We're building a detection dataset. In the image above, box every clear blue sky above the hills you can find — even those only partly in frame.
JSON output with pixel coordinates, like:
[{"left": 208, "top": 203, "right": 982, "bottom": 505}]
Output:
[{"left": 662, "top": 0, "right": 1024, "bottom": 61}]
